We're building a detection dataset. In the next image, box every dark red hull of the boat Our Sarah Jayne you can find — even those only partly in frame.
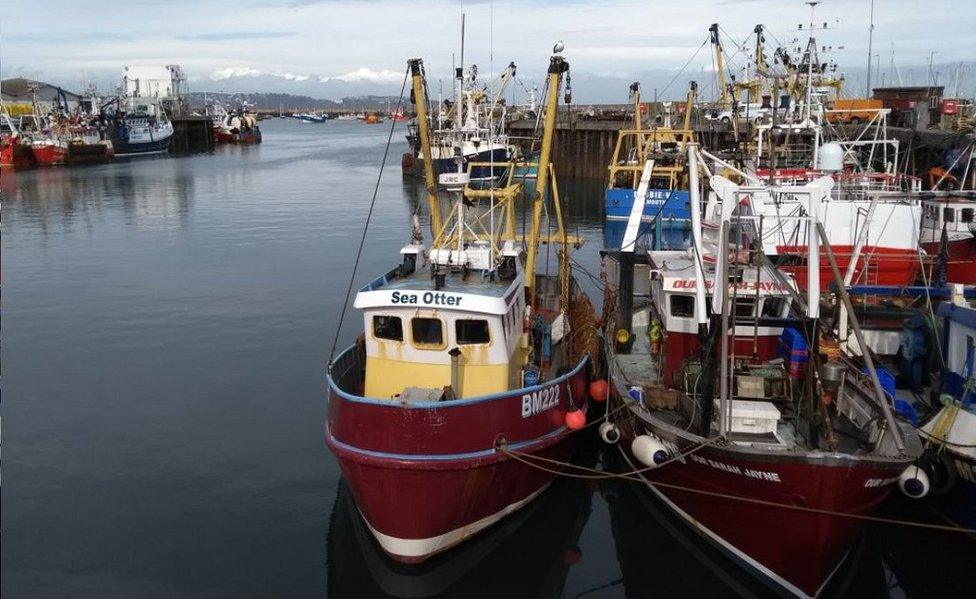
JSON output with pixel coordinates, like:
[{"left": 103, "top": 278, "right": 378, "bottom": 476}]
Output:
[{"left": 619, "top": 404, "right": 911, "bottom": 596}]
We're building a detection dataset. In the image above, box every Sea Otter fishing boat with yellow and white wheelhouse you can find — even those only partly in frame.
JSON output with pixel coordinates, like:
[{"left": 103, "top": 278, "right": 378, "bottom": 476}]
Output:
[{"left": 325, "top": 55, "right": 596, "bottom": 563}]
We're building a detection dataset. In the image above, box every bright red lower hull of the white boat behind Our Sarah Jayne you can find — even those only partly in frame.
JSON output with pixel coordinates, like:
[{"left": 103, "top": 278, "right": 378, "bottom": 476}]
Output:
[{"left": 776, "top": 245, "right": 922, "bottom": 290}]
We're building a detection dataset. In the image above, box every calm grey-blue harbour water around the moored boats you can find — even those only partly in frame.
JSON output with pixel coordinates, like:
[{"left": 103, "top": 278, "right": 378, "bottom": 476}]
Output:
[{"left": 0, "top": 120, "right": 972, "bottom": 598}]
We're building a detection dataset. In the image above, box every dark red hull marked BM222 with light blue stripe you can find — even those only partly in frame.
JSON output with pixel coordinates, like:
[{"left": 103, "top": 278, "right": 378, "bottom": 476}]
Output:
[{"left": 325, "top": 350, "right": 587, "bottom": 562}]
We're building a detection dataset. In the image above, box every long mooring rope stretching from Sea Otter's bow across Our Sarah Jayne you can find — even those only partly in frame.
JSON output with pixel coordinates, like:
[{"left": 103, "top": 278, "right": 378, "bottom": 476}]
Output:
[{"left": 498, "top": 441, "right": 976, "bottom": 535}]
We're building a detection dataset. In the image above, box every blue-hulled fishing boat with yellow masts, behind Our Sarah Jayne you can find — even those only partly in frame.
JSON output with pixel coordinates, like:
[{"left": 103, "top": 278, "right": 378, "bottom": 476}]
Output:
[{"left": 604, "top": 82, "right": 698, "bottom": 249}]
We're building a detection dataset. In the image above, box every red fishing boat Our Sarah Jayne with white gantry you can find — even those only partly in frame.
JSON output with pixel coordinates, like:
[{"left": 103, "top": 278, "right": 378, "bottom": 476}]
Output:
[{"left": 601, "top": 144, "right": 927, "bottom": 596}]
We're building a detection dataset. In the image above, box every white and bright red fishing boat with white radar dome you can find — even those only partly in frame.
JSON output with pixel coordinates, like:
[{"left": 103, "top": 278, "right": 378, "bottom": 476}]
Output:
[{"left": 709, "top": 11, "right": 924, "bottom": 287}]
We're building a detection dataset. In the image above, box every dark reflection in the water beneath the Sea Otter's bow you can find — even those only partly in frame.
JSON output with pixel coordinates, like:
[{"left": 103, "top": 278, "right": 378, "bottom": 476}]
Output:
[{"left": 327, "top": 478, "right": 592, "bottom": 598}]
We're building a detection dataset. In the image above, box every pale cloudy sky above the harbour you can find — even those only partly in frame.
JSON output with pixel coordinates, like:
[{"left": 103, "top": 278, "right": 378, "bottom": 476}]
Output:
[{"left": 0, "top": 0, "right": 976, "bottom": 102}]
